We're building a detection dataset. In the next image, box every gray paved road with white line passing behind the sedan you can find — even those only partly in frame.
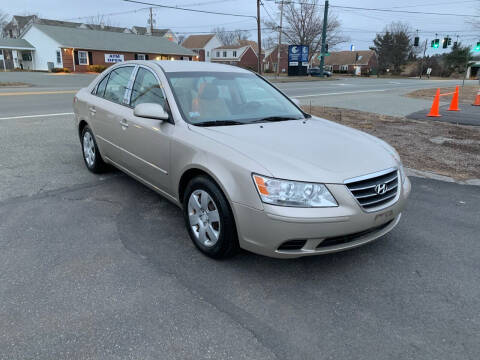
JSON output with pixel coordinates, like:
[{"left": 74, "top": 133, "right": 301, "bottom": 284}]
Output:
[{"left": 0, "top": 73, "right": 476, "bottom": 117}]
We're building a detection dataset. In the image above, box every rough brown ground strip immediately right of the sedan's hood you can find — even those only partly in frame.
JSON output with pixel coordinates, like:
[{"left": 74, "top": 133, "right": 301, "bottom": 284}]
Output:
[{"left": 304, "top": 106, "right": 480, "bottom": 180}]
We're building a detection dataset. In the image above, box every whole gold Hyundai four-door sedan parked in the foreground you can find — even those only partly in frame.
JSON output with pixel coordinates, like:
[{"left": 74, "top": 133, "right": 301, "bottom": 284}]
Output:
[{"left": 74, "top": 61, "right": 411, "bottom": 258}]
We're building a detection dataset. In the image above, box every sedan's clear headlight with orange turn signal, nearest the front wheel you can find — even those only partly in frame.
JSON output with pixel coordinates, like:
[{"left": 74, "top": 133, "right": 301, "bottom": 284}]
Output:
[{"left": 253, "top": 174, "right": 338, "bottom": 207}]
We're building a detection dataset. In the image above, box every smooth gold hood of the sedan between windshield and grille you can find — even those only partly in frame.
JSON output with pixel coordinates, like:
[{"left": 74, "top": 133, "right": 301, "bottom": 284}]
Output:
[{"left": 190, "top": 117, "right": 398, "bottom": 183}]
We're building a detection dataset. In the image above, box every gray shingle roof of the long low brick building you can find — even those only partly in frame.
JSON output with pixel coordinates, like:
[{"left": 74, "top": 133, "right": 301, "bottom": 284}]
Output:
[{"left": 33, "top": 24, "right": 195, "bottom": 56}]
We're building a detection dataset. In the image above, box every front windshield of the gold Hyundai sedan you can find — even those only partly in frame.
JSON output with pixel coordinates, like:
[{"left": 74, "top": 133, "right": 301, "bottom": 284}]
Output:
[{"left": 167, "top": 72, "right": 305, "bottom": 126}]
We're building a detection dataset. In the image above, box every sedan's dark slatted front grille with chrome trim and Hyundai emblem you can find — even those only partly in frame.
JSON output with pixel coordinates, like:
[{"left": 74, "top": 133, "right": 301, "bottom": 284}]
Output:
[{"left": 345, "top": 169, "right": 398, "bottom": 211}]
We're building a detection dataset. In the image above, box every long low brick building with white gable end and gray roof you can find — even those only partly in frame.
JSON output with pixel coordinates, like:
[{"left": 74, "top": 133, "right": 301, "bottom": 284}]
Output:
[{"left": 22, "top": 23, "right": 195, "bottom": 71}]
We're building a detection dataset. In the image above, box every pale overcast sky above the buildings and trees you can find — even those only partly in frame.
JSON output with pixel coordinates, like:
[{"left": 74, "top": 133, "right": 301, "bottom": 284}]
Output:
[{"left": 0, "top": 0, "right": 480, "bottom": 55}]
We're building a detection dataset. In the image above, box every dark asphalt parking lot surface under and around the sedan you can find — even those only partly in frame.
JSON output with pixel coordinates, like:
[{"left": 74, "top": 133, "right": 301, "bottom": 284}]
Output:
[{"left": 0, "top": 74, "right": 480, "bottom": 359}]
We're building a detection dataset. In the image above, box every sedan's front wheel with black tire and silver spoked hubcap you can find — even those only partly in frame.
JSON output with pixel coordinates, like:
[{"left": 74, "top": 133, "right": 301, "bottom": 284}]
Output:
[{"left": 183, "top": 176, "right": 239, "bottom": 259}]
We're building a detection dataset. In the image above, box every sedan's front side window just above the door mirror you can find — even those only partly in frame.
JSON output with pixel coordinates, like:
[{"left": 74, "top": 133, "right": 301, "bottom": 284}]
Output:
[{"left": 130, "top": 68, "right": 165, "bottom": 107}]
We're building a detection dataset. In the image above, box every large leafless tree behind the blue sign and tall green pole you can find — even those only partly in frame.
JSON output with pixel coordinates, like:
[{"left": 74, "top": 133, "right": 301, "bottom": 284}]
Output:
[{"left": 265, "top": 0, "right": 348, "bottom": 58}]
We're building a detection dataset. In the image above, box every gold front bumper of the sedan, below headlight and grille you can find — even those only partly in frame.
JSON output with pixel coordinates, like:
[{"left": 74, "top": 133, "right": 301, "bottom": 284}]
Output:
[{"left": 233, "top": 178, "right": 411, "bottom": 258}]
